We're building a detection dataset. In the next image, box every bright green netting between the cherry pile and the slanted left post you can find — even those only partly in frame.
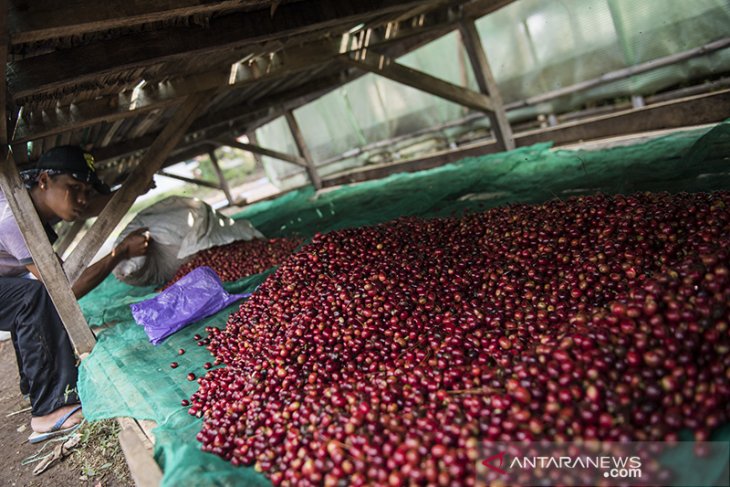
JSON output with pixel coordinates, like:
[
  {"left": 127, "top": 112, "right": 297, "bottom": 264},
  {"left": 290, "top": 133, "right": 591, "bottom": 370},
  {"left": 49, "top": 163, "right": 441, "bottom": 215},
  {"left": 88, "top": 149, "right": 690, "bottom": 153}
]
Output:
[{"left": 79, "top": 273, "right": 269, "bottom": 486}]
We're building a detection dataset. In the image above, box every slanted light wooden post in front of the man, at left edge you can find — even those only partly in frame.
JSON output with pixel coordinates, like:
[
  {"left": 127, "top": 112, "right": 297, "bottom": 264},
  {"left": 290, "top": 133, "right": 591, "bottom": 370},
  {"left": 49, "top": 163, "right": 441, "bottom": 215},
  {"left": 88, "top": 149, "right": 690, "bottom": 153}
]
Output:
[{"left": 0, "top": 1, "right": 96, "bottom": 358}]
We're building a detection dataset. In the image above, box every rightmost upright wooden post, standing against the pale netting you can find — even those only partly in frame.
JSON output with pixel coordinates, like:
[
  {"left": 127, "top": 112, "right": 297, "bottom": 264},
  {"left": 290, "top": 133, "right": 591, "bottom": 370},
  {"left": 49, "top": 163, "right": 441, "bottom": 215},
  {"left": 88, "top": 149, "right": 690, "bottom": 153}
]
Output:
[{"left": 459, "top": 19, "right": 515, "bottom": 150}]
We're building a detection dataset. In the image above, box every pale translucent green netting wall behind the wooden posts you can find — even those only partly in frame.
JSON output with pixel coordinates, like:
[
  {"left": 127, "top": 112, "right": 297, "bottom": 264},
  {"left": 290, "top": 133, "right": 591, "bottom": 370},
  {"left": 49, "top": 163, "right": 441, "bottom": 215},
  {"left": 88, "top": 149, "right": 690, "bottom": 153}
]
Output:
[{"left": 256, "top": 0, "right": 730, "bottom": 189}]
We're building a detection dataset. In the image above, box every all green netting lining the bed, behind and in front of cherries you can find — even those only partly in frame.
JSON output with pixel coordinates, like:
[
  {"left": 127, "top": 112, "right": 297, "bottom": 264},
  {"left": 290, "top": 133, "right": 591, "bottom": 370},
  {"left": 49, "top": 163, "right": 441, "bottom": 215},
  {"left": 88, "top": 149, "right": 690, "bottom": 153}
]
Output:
[{"left": 79, "top": 121, "right": 730, "bottom": 486}]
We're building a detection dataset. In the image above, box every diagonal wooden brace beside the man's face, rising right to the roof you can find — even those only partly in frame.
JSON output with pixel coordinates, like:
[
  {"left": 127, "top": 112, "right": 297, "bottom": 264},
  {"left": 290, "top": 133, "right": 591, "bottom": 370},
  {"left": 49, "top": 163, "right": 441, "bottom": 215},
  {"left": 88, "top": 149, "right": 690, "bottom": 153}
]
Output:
[{"left": 65, "top": 93, "right": 211, "bottom": 282}]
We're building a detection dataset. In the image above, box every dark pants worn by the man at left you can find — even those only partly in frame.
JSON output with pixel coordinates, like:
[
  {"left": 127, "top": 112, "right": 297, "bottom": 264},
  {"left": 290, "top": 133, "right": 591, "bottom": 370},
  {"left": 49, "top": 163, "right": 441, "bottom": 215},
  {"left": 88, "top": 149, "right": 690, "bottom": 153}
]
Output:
[{"left": 0, "top": 277, "right": 79, "bottom": 416}]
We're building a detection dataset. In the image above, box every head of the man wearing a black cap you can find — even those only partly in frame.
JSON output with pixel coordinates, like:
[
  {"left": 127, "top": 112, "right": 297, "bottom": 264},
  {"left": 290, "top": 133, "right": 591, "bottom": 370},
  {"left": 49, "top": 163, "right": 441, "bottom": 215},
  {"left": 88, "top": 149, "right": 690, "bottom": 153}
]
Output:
[{"left": 21, "top": 145, "right": 109, "bottom": 221}]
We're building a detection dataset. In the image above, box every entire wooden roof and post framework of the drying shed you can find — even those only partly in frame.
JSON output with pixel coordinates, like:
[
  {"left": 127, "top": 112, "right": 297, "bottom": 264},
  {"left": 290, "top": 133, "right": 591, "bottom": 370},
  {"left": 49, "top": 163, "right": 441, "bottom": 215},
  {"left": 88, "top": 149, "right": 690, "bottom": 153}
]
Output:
[{"left": 0, "top": 0, "right": 730, "bottom": 485}]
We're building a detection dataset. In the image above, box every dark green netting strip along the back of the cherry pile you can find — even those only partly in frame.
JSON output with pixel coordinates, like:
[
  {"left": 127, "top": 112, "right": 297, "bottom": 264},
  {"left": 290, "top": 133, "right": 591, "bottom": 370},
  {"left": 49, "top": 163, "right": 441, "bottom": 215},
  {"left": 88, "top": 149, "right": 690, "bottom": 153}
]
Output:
[{"left": 234, "top": 121, "right": 730, "bottom": 237}]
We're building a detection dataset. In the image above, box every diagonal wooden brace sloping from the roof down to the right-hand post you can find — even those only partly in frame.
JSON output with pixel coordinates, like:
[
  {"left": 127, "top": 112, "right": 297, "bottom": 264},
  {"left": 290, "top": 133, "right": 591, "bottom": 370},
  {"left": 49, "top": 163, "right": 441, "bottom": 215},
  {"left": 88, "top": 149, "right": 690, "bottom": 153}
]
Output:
[{"left": 342, "top": 49, "right": 494, "bottom": 112}]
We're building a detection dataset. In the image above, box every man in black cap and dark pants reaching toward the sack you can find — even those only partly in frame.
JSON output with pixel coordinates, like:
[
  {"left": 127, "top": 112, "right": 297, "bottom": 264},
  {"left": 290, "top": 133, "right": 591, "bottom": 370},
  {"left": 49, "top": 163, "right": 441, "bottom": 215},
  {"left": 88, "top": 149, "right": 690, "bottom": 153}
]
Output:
[{"left": 0, "top": 146, "right": 149, "bottom": 443}]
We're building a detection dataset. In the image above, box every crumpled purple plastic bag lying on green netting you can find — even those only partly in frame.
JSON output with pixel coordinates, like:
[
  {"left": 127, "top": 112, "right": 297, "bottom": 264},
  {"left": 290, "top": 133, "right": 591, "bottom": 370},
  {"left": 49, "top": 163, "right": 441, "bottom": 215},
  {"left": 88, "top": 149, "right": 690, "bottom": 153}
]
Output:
[{"left": 130, "top": 266, "right": 251, "bottom": 345}]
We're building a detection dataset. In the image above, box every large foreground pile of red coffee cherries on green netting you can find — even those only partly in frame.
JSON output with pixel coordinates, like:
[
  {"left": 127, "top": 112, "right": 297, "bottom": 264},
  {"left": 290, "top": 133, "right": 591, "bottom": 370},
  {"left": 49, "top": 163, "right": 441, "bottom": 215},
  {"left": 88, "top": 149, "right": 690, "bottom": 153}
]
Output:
[{"left": 189, "top": 192, "right": 730, "bottom": 486}]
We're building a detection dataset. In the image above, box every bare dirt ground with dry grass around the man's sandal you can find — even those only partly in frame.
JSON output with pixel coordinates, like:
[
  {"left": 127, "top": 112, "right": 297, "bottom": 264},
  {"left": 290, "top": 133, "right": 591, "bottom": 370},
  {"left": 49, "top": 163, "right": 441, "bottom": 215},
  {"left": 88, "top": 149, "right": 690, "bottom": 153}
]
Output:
[{"left": 0, "top": 341, "right": 134, "bottom": 487}]
